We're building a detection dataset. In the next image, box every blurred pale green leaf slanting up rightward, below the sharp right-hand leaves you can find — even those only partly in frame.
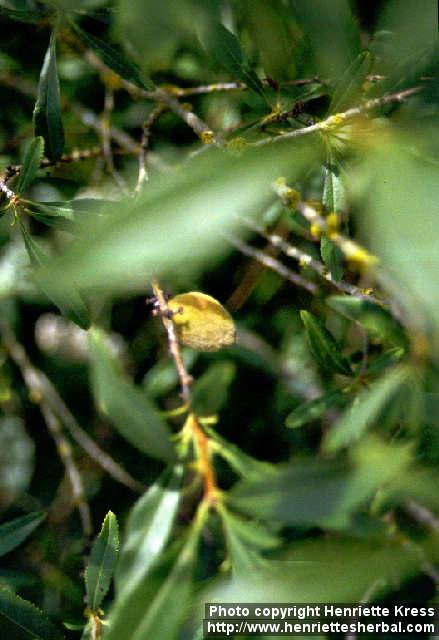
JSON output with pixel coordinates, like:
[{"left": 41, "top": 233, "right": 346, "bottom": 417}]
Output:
[{"left": 323, "top": 366, "right": 408, "bottom": 453}]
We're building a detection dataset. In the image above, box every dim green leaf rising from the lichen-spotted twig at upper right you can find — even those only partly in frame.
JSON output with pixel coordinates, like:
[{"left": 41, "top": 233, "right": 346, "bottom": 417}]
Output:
[{"left": 328, "top": 51, "right": 372, "bottom": 114}]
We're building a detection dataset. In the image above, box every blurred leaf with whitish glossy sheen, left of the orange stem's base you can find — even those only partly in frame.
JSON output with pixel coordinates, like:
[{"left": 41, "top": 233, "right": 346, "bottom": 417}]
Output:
[{"left": 115, "top": 465, "right": 183, "bottom": 597}]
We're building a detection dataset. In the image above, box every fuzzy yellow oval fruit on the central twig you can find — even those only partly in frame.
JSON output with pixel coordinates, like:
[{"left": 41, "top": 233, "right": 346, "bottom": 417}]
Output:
[{"left": 168, "top": 291, "right": 236, "bottom": 351}]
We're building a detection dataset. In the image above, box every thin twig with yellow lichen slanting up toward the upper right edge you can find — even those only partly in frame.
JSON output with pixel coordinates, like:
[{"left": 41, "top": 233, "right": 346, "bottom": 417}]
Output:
[{"left": 254, "top": 87, "right": 421, "bottom": 147}]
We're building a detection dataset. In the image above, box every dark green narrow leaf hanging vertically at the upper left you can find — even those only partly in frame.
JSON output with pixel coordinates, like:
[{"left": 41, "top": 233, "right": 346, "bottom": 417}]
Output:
[{"left": 34, "top": 33, "right": 64, "bottom": 161}]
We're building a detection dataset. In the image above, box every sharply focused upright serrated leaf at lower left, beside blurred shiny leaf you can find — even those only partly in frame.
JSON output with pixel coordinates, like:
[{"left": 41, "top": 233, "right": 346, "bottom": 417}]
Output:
[{"left": 85, "top": 511, "right": 119, "bottom": 611}]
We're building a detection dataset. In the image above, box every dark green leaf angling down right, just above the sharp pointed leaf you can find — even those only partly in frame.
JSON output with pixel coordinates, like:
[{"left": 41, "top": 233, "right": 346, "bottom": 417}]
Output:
[{"left": 326, "top": 296, "right": 407, "bottom": 349}]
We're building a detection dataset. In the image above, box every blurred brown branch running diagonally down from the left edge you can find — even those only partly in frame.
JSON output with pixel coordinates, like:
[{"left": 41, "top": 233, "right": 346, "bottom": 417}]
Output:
[{"left": 0, "top": 322, "right": 146, "bottom": 493}]
